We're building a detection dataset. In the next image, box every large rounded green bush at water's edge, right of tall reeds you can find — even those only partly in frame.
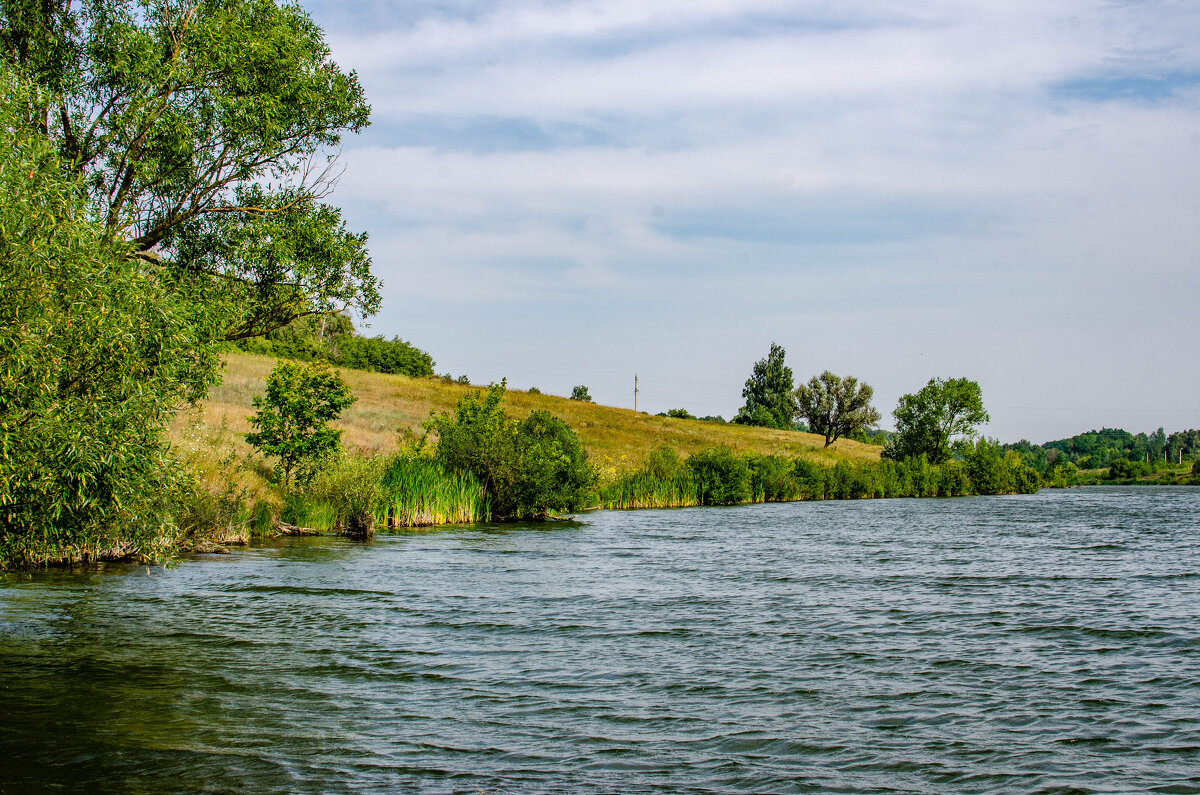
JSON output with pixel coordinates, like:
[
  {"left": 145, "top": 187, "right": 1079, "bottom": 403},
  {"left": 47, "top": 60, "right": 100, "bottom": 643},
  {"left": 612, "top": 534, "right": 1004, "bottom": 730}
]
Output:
[{"left": 426, "top": 383, "right": 595, "bottom": 519}]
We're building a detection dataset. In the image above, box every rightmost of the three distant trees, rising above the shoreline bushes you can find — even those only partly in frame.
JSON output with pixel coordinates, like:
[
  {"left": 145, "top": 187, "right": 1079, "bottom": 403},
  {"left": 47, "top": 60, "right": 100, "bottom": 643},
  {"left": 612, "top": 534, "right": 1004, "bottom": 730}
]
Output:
[{"left": 882, "top": 378, "right": 990, "bottom": 464}]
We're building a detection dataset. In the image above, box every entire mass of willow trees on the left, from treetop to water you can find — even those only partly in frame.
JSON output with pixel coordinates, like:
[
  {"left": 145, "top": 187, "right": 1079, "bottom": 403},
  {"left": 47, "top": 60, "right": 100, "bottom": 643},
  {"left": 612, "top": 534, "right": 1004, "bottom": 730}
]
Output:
[{"left": 0, "top": 0, "right": 379, "bottom": 564}]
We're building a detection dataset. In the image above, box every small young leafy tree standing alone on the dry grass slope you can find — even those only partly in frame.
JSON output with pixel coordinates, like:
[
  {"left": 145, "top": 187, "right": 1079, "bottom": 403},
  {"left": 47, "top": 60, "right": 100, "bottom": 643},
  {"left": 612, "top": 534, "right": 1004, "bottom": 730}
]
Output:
[{"left": 246, "top": 360, "right": 356, "bottom": 489}]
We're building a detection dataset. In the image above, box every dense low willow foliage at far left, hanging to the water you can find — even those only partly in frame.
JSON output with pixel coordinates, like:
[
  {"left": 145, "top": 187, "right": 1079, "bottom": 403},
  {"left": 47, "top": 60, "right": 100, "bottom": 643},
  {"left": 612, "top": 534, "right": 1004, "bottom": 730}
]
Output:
[{"left": 0, "top": 70, "right": 217, "bottom": 566}]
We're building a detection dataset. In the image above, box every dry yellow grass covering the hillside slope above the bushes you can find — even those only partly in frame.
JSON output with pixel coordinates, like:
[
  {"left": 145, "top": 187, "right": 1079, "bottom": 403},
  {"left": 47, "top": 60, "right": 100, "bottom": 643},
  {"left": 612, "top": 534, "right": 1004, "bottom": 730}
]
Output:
[{"left": 173, "top": 353, "right": 880, "bottom": 477}]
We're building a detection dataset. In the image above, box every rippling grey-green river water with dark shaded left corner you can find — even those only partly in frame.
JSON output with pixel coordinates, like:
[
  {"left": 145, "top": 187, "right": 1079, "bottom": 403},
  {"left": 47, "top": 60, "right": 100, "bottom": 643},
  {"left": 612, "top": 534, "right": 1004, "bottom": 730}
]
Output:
[{"left": 0, "top": 486, "right": 1200, "bottom": 795}]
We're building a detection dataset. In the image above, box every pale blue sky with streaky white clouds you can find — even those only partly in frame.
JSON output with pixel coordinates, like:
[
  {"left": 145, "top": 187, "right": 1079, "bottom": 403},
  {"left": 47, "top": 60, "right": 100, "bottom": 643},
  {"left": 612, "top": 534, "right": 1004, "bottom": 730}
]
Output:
[{"left": 295, "top": 0, "right": 1200, "bottom": 442}]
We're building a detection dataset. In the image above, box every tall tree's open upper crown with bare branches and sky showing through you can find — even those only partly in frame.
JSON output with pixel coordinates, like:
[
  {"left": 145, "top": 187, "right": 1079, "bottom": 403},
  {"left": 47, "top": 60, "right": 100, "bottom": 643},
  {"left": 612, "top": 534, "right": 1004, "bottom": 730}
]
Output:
[{"left": 0, "top": 0, "right": 379, "bottom": 339}]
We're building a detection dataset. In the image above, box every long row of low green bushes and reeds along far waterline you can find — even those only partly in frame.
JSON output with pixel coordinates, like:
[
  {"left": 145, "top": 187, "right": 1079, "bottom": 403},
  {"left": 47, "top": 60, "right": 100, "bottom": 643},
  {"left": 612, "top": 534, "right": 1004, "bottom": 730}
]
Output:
[{"left": 600, "top": 440, "right": 1040, "bottom": 509}]
